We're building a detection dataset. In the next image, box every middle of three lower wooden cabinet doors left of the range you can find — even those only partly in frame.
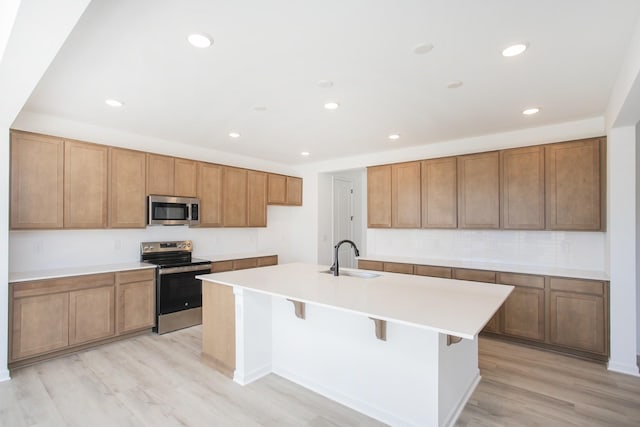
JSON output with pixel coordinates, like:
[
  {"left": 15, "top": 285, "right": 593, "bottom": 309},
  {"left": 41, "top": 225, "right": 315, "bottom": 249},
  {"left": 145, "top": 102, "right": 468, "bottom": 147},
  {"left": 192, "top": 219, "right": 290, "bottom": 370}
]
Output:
[{"left": 69, "top": 286, "right": 115, "bottom": 345}]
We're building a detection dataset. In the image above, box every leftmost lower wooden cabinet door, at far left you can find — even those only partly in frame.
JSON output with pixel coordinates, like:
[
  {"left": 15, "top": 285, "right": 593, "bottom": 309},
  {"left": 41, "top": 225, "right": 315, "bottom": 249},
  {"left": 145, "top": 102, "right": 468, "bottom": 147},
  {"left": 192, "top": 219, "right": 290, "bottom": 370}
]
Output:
[{"left": 11, "top": 292, "right": 69, "bottom": 360}]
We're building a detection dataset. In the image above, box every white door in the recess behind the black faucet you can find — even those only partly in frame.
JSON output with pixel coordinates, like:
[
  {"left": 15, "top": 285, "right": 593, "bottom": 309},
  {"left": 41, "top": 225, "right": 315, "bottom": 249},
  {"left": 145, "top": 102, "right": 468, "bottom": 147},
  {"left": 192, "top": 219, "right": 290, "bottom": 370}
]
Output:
[{"left": 332, "top": 176, "right": 356, "bottom": 268}]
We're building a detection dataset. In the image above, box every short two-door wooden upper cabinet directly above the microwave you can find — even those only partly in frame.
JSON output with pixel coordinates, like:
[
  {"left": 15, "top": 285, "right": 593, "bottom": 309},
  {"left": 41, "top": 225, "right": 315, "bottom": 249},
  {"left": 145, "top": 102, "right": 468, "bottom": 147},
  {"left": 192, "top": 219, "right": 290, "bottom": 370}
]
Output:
[{"left": 147, "top": 154, "right": 197, "bottom": 197}]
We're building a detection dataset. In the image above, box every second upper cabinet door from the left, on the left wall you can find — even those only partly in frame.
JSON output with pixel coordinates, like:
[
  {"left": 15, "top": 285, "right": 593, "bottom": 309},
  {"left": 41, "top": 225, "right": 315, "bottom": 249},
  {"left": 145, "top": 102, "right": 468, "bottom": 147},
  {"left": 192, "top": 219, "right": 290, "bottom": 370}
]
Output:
[{"left": 64, "top": 141, "right": 109, "bottom": 228}]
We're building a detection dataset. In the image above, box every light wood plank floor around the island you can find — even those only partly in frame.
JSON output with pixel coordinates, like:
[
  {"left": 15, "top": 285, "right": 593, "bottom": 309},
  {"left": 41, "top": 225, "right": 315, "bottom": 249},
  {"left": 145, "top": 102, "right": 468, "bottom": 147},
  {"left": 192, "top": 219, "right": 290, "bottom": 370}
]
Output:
[{"left": 0, "top": 327, "right": 640, "bottom": 427}]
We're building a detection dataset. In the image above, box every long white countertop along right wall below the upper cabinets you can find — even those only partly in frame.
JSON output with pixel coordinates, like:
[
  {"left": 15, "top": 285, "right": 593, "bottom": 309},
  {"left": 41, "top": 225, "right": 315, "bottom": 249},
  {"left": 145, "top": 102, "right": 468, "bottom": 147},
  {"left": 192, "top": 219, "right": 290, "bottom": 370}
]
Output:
[{"left": 358, "top": 254, "right": 609, "bottom": 280}]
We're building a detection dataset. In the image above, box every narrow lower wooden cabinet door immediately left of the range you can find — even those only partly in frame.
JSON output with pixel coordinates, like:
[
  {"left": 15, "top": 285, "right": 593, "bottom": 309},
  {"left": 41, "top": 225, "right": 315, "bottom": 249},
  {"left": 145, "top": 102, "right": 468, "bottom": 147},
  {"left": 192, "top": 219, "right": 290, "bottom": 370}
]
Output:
[{"left": 118, "top": 279, "right": 156, "bottom": 334}]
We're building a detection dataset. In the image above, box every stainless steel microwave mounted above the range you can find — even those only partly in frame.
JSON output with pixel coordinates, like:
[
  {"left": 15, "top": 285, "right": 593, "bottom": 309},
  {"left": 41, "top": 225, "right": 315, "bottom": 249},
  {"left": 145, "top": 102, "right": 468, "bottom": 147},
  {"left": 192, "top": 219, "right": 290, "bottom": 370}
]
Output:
[{"left": 147, "top": 195, "right": 200, "bottom": 225}]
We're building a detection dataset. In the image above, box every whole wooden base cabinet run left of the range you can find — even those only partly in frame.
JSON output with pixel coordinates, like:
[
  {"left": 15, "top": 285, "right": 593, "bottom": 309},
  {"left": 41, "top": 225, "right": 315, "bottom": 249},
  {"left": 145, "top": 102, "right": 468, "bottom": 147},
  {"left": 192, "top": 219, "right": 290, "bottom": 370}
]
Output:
[{"left": 9, "top": 269, "right": 155, "bottom": 368}]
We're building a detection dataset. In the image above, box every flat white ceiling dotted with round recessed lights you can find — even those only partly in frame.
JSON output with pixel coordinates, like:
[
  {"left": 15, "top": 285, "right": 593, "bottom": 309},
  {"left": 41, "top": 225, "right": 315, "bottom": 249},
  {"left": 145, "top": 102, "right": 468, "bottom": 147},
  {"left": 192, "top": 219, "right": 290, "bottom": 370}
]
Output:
[{"left": 18, "top": 0, "right": 640, "bottom": 164}]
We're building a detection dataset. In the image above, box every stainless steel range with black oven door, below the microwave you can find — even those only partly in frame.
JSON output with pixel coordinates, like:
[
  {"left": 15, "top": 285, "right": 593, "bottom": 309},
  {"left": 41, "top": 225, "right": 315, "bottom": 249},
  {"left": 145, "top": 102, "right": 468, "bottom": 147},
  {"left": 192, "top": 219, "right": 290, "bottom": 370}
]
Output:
[{"left": 140, "top": 240, "right": 211, "bottom": 334}]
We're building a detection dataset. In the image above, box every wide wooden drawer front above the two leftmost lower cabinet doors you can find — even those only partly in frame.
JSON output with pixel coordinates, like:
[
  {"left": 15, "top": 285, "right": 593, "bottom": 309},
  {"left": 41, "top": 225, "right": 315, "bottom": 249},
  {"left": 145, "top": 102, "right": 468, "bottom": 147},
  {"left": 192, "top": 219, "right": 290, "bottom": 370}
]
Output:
[{"left": 12, "top": 273, "right": 115, "bottom": 298}]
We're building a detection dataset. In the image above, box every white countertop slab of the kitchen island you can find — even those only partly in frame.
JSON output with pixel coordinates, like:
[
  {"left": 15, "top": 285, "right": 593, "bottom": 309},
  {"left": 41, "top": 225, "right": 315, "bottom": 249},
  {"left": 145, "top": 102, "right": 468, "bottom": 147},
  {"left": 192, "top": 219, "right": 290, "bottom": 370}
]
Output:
[{"left": 197, "top": 263, "right": 513, "bottom": 339}]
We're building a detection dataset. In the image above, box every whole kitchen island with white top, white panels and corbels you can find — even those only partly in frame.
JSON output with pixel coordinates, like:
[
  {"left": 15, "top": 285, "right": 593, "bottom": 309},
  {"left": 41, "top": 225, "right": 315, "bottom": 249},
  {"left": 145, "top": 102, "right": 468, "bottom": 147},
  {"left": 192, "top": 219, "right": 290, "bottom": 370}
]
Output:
[{"left": 198, "top": 263, "right": 513, "bottom": 426}]
